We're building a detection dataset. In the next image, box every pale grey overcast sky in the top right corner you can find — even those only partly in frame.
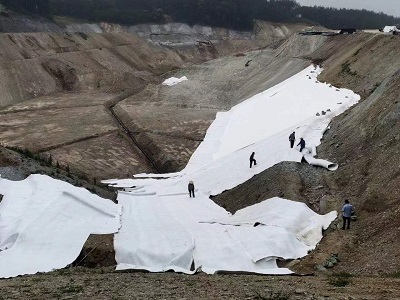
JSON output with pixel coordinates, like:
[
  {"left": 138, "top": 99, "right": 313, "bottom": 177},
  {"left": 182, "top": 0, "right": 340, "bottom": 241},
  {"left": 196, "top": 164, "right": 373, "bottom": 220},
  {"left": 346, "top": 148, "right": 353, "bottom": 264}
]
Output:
[{"left": 297, "top": 0, "right": 400, "bottom": 17}]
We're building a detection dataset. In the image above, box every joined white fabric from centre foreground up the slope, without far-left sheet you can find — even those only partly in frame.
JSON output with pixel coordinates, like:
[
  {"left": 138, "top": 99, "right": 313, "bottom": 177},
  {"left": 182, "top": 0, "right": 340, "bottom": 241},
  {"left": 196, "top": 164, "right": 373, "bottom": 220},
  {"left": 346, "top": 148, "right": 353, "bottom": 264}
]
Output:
[{"left": 106, "top": 66, "right": 360, "bottom": 274}]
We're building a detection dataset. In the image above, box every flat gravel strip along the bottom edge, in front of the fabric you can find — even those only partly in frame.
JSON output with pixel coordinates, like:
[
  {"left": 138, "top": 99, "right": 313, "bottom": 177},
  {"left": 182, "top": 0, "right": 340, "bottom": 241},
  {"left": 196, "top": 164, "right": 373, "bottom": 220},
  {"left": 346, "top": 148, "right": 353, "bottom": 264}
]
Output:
[{"left": 0, "top": 268, "right": 400, "bottom": 300}]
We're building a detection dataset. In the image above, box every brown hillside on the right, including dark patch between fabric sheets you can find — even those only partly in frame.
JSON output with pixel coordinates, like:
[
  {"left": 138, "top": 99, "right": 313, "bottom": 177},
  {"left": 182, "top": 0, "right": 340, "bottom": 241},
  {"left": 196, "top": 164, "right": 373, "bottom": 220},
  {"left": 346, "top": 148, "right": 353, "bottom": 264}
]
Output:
[{"left": 215, "top": 34, "right": 400, "bottom": 275}]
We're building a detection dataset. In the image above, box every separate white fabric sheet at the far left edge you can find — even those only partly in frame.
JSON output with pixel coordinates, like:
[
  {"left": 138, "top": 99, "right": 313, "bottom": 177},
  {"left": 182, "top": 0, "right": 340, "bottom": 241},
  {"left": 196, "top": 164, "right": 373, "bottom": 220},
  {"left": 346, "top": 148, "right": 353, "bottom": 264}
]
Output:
[{"left": 0, "top": 175, "right": 121, "bottom": 278}]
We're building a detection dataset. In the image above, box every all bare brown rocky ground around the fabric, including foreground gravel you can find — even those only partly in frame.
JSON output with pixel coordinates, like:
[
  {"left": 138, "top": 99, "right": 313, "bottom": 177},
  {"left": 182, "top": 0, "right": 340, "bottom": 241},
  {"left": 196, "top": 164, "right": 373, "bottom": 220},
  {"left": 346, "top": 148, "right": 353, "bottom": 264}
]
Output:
[{"left": 0, "top": 12, "right": 400, "bottom": 299}]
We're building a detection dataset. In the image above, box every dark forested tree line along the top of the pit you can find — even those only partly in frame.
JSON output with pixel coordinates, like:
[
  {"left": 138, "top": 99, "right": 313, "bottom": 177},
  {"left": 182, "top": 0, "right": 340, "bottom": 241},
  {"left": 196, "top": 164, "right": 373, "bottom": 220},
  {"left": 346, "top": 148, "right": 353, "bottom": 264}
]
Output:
[{"left": 0, "top": 0, "right": 400, "bottom": 30}]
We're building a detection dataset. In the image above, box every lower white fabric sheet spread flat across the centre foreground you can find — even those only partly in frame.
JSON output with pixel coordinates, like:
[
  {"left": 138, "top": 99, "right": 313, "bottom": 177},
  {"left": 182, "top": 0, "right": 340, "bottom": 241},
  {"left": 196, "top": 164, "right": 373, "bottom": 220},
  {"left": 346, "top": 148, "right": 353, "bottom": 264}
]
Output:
[{"left": 114, "top": 193, "right": 336, "bottom": 274}]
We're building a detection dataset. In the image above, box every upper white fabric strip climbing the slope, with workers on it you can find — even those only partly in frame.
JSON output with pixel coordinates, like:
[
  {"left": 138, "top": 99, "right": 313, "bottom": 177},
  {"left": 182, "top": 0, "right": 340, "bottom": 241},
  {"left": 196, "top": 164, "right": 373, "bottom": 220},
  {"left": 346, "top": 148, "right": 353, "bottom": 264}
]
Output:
[{"left": 105, "top": 66, "right": 360, "bottom": 195}]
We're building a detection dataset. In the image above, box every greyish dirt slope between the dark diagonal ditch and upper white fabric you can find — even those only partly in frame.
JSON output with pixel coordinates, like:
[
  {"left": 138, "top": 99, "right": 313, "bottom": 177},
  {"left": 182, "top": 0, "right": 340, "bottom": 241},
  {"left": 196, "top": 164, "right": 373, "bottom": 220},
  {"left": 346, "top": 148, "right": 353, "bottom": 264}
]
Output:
[{"left": 115, "top": 44, "right": 322, "bottom": 172}]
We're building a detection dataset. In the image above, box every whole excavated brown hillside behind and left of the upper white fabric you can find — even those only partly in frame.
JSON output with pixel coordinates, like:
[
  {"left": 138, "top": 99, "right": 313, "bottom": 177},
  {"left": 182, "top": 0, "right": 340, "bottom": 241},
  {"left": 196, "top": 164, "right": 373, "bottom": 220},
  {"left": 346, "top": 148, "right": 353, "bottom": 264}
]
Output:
[{"left": 0, "top": 17, "right": 316, "bottom": 179}]
